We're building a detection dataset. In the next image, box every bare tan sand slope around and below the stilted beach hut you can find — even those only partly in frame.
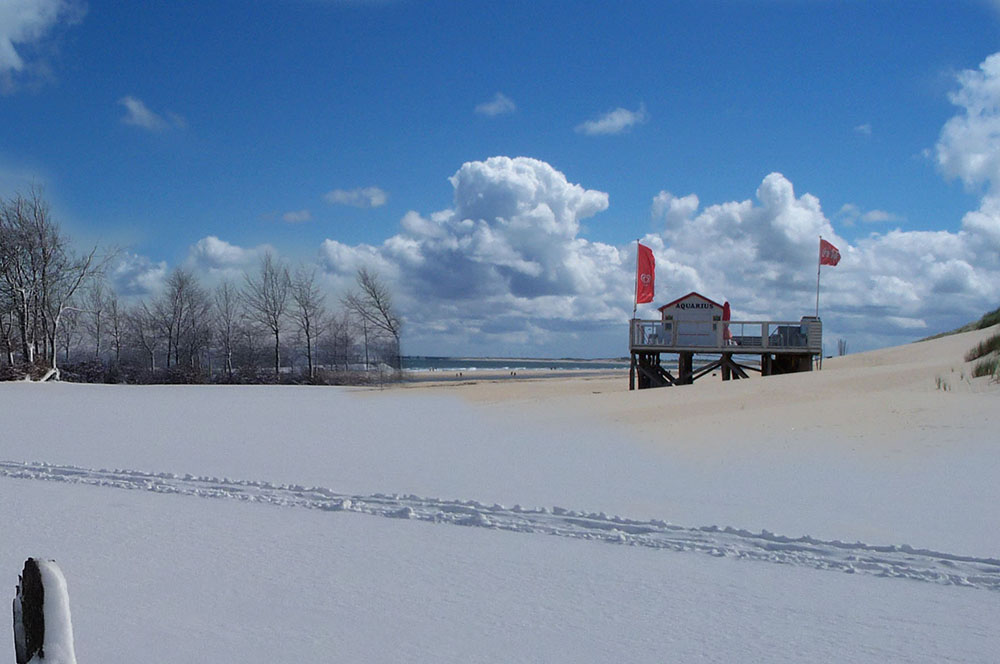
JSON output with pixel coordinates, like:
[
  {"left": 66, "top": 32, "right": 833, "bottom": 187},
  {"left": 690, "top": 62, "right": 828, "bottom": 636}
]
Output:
[{"left": 401, "top": 326, "right": 1000, "bottom": 451}]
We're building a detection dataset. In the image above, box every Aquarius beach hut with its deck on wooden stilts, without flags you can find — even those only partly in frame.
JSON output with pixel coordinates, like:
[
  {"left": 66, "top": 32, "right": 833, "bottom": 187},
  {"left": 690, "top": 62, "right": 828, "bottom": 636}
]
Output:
[{"left": 629, "top": 292, "right": 823, "bottom": 390}]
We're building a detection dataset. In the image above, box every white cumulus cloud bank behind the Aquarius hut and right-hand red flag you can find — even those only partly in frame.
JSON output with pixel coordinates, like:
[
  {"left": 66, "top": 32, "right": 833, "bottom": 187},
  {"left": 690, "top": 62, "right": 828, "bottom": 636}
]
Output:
[{"left": 645, "top": 173, "right": 1000, "bottom": 348}]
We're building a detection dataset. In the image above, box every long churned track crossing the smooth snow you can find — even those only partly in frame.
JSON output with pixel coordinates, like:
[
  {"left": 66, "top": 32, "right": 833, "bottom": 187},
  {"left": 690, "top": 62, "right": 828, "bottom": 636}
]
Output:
[{"left": 0, "top": 461, "right": 1000, "bottom": 591}]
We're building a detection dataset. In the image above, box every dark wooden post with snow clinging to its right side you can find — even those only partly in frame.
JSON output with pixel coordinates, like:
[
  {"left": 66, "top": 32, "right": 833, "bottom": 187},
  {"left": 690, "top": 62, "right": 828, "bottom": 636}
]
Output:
[{"left": 14, "top": 558, "right": 76, "bottom": 664}]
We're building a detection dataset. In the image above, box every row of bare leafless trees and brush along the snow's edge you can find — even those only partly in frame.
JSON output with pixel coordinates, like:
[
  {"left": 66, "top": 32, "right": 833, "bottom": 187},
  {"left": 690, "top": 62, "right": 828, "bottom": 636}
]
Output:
[{"left": 0, "top": 189, "right": 402, "bottom": 383}]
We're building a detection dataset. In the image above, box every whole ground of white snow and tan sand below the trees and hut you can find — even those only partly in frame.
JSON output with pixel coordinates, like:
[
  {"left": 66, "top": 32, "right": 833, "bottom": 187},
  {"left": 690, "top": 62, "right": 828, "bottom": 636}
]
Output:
[{"left": 0, "top": 328, "right": 1000, "bottom": 662}]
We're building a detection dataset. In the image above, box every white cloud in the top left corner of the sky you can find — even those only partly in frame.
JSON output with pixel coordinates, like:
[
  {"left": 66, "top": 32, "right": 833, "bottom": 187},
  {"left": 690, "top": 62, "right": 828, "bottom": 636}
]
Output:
[{"left": 0, "top": 0, "right": 86, "bottom": 91}]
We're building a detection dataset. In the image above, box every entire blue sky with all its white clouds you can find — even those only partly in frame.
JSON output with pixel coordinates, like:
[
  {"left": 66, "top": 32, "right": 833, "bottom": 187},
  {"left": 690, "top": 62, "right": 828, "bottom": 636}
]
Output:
[{"left": 0, "top": 0, "right": 1000, "bottom": 357}]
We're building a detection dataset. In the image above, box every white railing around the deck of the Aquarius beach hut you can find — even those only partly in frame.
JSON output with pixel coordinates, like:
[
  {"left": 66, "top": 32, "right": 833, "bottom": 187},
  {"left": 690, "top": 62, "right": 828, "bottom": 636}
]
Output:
[{"left": 629, "top": 317, "right": 823, "bottom": 353}]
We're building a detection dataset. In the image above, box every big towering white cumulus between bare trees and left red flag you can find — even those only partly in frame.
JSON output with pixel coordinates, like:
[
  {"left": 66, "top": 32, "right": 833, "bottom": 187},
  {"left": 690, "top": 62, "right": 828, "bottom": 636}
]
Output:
[{"left": 321, "top": 157, "right": 631, "bottom": 353}]
